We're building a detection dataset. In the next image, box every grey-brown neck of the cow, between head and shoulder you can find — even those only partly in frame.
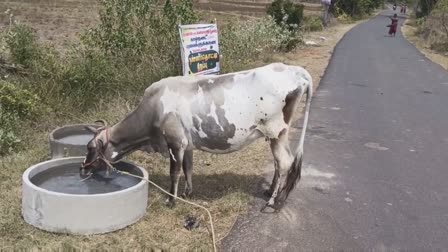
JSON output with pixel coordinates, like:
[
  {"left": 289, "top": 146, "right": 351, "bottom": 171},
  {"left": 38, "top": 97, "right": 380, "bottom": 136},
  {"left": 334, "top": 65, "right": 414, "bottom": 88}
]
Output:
[{"left": 110, "top": 103, "right": 153, "bottom": 154}]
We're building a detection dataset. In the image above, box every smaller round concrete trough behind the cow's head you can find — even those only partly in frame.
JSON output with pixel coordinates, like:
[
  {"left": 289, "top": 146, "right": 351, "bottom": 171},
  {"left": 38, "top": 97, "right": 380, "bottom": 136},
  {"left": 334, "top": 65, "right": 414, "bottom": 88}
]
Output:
[{"left": 49, "top": 124, "right": 101, "bottom": 159}]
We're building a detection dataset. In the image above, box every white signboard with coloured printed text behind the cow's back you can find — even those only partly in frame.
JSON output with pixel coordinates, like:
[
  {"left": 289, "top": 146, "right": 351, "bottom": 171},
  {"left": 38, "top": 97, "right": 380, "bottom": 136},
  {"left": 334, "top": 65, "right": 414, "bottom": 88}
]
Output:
[{"left": 179, "top": 24, "right": 221, "bottom": 76}]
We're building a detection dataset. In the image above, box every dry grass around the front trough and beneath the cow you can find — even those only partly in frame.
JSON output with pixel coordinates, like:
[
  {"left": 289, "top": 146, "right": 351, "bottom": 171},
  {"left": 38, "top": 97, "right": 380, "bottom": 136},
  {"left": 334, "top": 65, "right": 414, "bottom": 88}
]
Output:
[{"left": 0, "top": 146, "right": 268, "bottom": 250}]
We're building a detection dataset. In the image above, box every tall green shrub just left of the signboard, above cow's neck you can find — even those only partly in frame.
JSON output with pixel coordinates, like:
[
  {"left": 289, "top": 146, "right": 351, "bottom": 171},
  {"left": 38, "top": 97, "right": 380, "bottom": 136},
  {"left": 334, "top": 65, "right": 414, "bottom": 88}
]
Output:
[{"left": 61, "top": 0, "right": 197, "bottom": 107}]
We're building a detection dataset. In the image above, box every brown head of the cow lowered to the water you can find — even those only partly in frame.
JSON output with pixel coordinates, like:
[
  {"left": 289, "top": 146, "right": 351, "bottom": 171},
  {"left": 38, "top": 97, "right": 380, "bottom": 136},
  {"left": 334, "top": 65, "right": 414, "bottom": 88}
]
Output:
[{"left": 79, "top": 120, "right": 117, "bottom": 177}]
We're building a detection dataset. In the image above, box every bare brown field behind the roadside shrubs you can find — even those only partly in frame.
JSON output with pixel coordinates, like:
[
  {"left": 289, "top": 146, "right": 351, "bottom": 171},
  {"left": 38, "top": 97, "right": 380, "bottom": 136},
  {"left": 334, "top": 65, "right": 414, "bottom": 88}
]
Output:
[{"left": 0, "top": 0, "right": 321, "bottom": 51}]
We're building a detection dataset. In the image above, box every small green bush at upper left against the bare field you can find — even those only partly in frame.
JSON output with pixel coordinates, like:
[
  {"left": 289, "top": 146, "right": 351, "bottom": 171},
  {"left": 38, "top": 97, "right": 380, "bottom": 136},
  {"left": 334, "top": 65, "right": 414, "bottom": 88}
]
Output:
[{"left": 6, "top": 24, "right": 40, "bottom": 67}]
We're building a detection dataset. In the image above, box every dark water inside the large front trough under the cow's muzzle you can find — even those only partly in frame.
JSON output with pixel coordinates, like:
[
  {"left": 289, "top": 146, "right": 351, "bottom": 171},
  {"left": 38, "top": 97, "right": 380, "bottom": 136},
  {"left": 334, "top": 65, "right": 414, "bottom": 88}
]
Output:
[{"left": 30, "top": 163, "right": 142, "bottom": 195}]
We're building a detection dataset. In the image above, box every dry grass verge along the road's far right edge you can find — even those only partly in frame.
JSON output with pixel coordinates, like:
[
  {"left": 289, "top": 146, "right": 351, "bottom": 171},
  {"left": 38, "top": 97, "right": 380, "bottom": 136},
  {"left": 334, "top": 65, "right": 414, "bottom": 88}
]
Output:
[{"left": 401, "top": 16, "right": 448, "bottom": 70}]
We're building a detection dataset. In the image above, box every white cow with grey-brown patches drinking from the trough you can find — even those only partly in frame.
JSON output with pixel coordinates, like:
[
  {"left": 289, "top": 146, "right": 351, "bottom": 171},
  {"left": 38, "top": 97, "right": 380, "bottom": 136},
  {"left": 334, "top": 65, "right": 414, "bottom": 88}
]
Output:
[{"left": 80, "top": 63, "right": 312, "bottom": 209}]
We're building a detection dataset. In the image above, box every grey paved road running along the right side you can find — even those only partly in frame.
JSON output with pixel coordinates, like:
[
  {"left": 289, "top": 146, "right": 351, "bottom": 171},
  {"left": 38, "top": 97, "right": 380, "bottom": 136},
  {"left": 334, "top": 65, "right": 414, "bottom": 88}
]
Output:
[{"left": 223, "top": 12, "right": 448, "bottom": 251}]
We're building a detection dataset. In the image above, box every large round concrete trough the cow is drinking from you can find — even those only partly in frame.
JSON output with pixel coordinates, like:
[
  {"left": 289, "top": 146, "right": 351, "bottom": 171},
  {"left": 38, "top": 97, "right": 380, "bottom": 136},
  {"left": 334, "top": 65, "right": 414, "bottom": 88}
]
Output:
[{"left": 22, "top": 157, "right": 148, "bottom": 234}]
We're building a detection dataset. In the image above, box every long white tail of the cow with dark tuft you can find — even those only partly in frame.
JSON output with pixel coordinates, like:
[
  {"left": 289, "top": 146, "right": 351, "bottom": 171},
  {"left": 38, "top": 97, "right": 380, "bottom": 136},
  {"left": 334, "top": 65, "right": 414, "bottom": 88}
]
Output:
[{"left": 276, "top": 81, "right": 313, "bottom": 204}]
